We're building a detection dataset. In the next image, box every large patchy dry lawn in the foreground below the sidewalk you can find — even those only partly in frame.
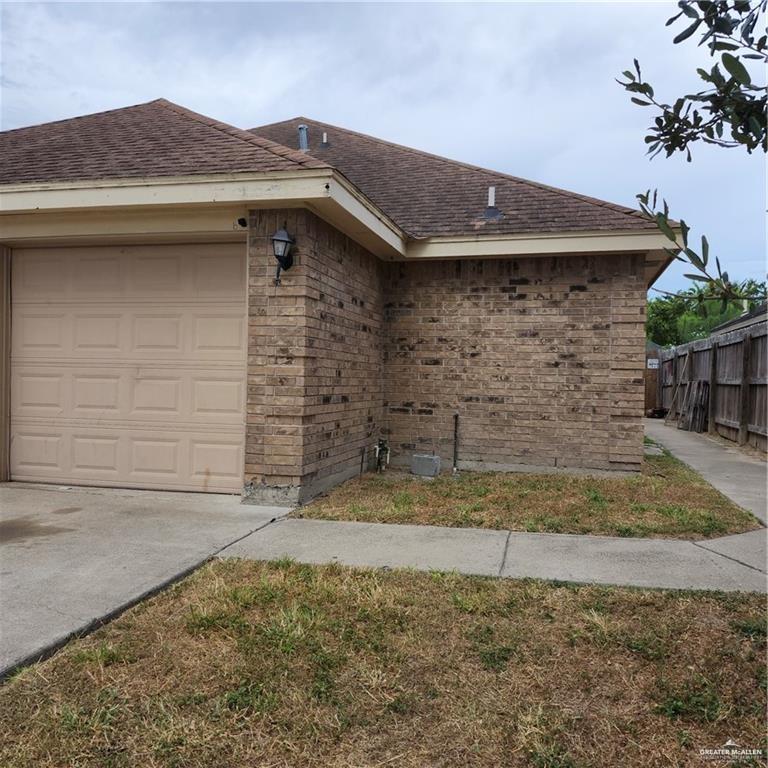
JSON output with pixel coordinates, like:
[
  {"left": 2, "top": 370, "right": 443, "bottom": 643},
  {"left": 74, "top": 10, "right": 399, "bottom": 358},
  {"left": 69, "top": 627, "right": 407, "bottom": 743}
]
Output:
[{"left": 0, "top": 560, "right": 766, "bottom": 768}]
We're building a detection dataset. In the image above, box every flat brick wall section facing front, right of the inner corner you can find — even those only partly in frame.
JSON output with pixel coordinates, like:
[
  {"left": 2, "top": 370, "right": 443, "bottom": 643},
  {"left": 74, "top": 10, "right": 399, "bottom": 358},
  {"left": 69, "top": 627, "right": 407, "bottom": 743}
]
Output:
[{"left": 385, "top": 255, "right": 645, "bottom": 469}]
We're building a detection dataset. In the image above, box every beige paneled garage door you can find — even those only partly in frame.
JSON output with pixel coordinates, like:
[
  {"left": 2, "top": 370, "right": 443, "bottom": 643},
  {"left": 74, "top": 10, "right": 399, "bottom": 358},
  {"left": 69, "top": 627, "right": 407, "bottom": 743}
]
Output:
[{"left": 11, "top": 244, "right": 247, "bottom": 491}]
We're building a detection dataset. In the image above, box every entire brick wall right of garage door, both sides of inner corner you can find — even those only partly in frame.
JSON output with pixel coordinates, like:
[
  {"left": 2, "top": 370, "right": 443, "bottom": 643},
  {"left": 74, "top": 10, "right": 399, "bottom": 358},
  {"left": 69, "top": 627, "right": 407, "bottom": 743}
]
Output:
[{"left": 245, "top": 209, "right": 645, "bottom": 503}]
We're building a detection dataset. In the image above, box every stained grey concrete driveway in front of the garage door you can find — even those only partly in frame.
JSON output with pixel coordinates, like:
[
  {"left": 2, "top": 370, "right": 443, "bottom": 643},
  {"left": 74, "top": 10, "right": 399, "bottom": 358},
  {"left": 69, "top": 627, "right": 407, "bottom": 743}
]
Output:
[{"left": 0, "top": 483, "right": 289, "bottom": 677}]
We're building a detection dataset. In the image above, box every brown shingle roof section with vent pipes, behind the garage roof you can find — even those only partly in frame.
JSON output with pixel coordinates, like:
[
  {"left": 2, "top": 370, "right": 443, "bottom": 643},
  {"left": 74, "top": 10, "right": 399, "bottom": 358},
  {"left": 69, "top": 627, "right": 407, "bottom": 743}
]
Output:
[{"left": 252, "top": 117, "right": 655, "bottom": 237}]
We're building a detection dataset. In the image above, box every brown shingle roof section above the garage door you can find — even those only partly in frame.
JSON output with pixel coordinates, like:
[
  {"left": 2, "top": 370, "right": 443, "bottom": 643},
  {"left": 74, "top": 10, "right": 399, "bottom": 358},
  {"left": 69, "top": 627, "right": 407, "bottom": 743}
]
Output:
[{"left": 0, "top": 99, "right": 328, "bottom": 184}]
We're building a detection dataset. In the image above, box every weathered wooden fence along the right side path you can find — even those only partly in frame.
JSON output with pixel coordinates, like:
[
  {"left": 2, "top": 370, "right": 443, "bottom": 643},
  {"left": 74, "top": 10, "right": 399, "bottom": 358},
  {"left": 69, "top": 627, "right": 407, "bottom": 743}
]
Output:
[{"left": 659, "top": 323, "right": 768, "bottom": 451}]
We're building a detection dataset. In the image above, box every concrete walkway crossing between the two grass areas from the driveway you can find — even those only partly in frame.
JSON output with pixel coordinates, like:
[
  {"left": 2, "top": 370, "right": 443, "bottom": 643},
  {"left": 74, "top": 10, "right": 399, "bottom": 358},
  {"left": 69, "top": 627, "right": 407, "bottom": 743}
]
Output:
[{"left": 219, "top": 519, "right": 766, "bottom": 592}]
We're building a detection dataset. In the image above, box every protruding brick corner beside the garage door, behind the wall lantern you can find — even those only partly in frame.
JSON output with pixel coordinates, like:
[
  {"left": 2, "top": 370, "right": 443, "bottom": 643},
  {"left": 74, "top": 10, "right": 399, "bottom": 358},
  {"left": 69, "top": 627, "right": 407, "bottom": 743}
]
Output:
[{"left": 245, "top": 209, "right": 384, "bottom": 503}]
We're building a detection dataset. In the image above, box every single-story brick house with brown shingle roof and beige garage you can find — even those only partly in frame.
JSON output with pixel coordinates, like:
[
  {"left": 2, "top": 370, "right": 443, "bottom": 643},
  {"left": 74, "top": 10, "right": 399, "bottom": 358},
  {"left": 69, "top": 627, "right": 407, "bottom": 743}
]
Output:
[{"left": 0, "top": 99, "right": 668, "bottom": 503}]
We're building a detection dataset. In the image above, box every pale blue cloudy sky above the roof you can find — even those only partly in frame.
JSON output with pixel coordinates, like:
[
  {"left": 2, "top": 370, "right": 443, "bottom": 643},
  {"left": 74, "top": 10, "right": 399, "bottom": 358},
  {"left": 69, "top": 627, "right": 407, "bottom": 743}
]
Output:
[{"left": 0, "top": 0, "right": 766, "bottom": 291}]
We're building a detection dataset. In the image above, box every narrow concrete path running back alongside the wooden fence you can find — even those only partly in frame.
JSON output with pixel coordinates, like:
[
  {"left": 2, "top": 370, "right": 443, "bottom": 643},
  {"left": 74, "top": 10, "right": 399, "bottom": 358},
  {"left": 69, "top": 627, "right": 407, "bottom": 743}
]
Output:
[{"left": 645, "top": 419, "right": 768, "bottom": 524}]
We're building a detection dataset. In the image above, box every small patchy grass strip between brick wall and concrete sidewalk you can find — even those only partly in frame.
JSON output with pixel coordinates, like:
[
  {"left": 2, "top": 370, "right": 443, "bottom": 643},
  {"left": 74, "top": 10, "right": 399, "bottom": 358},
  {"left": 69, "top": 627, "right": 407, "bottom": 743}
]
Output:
[{"left": 293, "top": 453, "right": 760, "bottom": 539}]
